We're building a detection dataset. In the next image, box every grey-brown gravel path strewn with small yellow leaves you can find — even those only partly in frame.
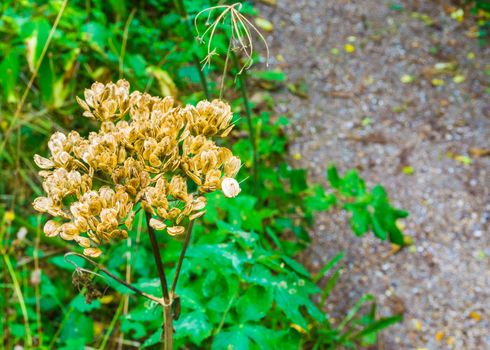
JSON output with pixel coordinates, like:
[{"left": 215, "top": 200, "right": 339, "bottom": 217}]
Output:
[{"left": 261, "top": 0, "right": 490, "bottom": 349}]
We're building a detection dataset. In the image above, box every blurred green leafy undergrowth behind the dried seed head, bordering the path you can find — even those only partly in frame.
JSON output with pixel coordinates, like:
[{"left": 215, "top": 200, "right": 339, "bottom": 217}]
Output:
[{"left": 0, "top": 0, "right": 488, "bottom": 349}]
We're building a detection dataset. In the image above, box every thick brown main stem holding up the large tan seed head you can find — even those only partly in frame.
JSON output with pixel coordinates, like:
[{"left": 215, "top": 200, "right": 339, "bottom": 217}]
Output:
[{"left": 145, "top": 212, "right": 174, "bottom": 350}]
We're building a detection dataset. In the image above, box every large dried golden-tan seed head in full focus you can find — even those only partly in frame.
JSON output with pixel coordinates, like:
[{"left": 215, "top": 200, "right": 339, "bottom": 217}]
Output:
[{"left": 33, "top": 80, "right": 241, "bottom": 257}]
